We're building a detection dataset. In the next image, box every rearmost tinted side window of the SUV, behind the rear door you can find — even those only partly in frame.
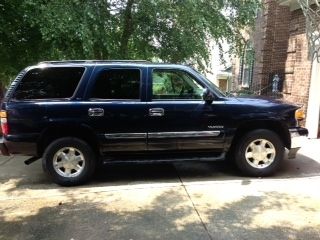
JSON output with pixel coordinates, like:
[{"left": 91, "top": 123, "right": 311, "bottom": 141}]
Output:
[{"left": 13, "top": 67, "right": 85, "bottom": 100}]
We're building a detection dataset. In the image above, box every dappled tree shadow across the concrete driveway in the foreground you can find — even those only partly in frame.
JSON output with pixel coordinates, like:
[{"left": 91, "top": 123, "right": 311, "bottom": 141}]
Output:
[{"left": 0, "top": 190, "right": 319, "bottom": 240}]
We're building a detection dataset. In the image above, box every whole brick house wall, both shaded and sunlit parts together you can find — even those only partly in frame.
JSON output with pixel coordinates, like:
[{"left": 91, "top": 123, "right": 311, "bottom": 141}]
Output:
[{"left": 253, "top": 0, "right": 311, "bottom": 114}]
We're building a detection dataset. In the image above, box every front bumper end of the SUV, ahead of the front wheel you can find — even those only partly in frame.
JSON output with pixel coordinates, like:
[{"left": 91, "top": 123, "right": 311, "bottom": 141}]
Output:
[{"left": 288, "top": 127, "right": 308, "bottom": 159}]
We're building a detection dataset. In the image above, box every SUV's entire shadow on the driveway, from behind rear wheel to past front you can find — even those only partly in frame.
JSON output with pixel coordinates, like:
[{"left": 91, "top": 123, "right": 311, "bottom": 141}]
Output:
[{"left": 0, "top": 154, "right": 320, "bottom": 192}]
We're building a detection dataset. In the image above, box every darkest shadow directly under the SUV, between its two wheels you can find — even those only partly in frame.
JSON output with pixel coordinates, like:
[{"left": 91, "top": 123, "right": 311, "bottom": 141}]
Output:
[{"left": 94, "top": 162, "right": 237, "bottom": 185}]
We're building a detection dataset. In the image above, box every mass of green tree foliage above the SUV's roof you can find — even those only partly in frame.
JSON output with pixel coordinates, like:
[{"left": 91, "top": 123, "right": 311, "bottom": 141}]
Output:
[{"left": 0, "top": 0, "right": 260, "bottom": 84}]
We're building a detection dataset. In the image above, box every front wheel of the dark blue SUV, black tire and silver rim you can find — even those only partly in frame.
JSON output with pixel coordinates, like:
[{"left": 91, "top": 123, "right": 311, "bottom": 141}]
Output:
[{"left": 234, "top": 129, "right": 284, "bottom": 177}]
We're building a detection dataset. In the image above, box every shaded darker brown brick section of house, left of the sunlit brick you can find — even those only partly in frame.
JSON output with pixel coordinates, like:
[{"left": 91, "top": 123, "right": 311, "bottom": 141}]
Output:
[{"left": 253, "top": 0, "right": 290, "bottom": 94}]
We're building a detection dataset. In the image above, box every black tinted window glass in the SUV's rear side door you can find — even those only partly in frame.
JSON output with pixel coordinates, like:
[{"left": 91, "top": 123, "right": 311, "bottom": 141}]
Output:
[{"left": 91, "top": 69, "right": 140, "bottom": 99}]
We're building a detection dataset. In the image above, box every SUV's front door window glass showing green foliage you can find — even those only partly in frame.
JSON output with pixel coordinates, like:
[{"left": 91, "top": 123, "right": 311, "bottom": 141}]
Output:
[{"left": 152, "top": 69, "right": 204, "bottom": 100}]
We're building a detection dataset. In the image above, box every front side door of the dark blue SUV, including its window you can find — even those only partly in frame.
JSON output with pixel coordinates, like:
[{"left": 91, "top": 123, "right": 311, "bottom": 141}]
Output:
[{"left": 148, "top": 68, "right": 225, "bottom": 150}]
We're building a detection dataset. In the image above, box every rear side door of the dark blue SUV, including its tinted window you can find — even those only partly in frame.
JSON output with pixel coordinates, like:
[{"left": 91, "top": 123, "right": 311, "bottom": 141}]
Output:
[{"left": 83, "top": 66, "right": 147, "bottom": 153}]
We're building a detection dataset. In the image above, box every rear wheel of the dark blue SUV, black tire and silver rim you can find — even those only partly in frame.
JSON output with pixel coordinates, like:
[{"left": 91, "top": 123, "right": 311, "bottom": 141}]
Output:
[{"left": 42, "top": 137, "right": 97, "bottom": 186}]
